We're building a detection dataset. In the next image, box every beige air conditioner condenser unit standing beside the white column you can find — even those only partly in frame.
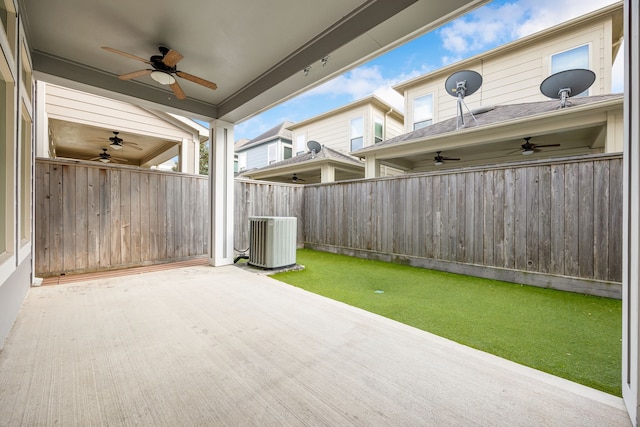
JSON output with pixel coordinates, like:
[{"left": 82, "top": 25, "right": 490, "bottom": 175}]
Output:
[{"left": 249, "top": 216, "right": 297, "bottom": 268}]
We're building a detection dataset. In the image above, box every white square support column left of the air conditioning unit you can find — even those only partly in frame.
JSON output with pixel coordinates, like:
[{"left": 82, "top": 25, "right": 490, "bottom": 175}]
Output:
[{"left": 209, "top": 120, "right": 234, "bottom": 267}]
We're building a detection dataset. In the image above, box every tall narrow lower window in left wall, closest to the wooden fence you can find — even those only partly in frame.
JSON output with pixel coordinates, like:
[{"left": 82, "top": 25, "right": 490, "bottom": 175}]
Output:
[{"left": 20, "top": 105, "right": 31, "bottom": 243}]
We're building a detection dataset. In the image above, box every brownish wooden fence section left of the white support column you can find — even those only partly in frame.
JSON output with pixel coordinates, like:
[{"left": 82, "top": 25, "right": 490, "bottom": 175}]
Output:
[{"left": 35, "top": 159, "right": 208, "bottom": 277}]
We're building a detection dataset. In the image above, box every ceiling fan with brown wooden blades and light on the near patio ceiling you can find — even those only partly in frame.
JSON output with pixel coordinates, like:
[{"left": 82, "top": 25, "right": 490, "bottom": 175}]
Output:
[{"left": 102, "top": 46, "right": 218, "bottom": 99}]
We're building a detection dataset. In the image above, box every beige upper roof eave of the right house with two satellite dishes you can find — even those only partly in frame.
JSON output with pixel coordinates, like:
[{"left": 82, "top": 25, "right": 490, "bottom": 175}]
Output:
[{"left": 392, "top": 2, "right": 623, "bottom": 95}]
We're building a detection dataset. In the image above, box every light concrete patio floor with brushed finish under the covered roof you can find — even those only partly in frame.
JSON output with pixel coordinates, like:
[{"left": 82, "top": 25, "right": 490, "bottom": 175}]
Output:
[{"left": 0, "top": 266, "right": 630, "bottom": 426}]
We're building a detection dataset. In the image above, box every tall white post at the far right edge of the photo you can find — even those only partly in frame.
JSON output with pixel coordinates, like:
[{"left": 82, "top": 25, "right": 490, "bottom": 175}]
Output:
[{"left": 622, "top": 0, "right": 640, "bottom": 426}]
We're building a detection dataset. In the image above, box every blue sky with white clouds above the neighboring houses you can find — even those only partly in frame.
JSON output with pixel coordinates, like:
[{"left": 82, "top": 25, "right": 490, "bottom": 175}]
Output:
[{"left": 234, "top": 0, "right": 624, "bottom": 141}]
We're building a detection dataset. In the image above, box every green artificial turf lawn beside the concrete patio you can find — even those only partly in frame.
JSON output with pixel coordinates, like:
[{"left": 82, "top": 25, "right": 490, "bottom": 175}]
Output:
[{"left": 273, "top": 249, "right": 622, "bottom": 396}]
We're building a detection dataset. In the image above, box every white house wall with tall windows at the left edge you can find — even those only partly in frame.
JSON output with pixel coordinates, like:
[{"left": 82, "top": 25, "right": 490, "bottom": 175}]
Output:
[{"left": 0, "top": 3, "right": 35, "bottom": 347}]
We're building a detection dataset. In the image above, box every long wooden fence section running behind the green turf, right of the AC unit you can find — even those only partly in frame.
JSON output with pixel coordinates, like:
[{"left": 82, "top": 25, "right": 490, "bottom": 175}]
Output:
[{"left": 304, "top": 155, "right": 622, "bottom": 296}]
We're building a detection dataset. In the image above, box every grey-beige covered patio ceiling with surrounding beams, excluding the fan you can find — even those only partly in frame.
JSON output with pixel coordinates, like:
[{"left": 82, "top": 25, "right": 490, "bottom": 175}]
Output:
[{"left": 20, "top": 0, "right": 487, "bottom": 123}]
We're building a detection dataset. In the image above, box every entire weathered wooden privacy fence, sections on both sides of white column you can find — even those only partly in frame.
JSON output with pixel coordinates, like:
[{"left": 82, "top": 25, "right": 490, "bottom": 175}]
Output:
[{"left": 35, "top": 155, "right": 622, "bottom": 297}]
